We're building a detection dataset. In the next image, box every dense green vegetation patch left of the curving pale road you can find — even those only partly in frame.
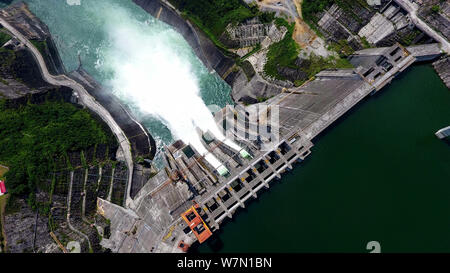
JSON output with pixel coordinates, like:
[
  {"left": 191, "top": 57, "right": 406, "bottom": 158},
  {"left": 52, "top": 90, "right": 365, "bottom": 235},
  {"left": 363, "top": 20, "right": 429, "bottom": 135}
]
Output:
[{"left": 0, "top": 101, "right": 112, "bottom": 196}]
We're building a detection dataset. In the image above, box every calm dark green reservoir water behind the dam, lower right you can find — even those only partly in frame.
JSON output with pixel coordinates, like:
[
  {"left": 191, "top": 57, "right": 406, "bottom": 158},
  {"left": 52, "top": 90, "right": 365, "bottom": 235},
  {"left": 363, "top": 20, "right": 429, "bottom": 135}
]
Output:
[{"left": 196, "top": 65, "right": 450, "bottom": 252}]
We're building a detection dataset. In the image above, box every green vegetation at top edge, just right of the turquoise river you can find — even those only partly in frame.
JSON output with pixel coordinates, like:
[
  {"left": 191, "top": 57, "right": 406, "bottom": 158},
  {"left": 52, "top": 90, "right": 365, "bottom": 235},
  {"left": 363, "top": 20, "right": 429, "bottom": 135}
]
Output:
[{"left": 169, "top": 0, "right": 258, "bottom": 47}]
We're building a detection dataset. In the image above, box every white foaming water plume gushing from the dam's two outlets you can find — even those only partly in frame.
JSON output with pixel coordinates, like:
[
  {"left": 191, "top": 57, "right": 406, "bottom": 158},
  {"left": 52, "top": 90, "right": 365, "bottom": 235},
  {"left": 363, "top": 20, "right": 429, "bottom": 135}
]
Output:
[{"left": 105, "top": 8, "right": 241, "bottom": 174}]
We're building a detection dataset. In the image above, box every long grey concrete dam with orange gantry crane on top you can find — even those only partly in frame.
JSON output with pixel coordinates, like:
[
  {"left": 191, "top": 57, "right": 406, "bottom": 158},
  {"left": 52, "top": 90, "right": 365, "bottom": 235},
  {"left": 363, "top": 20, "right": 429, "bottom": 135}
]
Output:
[{"left": 99, "top": 41, "right": 442, "bottom": 252}]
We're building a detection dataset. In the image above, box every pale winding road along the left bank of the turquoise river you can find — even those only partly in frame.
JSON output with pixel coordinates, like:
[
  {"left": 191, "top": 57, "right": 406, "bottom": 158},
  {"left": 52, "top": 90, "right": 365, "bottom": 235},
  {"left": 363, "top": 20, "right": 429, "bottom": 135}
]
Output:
[{"left": 0, "top": 17, "right": 133, "bottom": 206}]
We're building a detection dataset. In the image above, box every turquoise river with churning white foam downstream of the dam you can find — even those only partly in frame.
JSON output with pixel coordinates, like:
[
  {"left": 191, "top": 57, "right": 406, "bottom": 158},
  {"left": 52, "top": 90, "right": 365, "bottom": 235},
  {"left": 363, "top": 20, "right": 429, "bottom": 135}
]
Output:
[{"left": 19, "top": 0, "right": 233, "bottom": 165}]
